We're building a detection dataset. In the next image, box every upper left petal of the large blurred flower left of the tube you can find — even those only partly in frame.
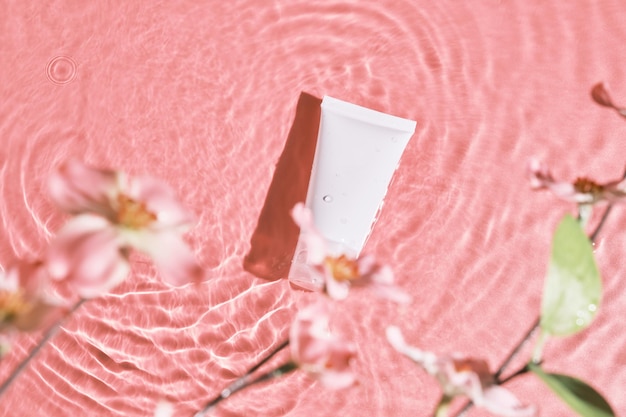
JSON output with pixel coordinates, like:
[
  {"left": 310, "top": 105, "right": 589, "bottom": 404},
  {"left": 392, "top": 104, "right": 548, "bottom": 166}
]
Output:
[{"left": 49, "top": 160, "right": 119, "bottom": 218}]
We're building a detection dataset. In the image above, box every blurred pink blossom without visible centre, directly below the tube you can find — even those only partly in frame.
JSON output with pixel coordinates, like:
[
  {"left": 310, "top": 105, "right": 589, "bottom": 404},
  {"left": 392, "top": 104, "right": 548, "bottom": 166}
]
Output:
[{"left": 289, "top": 302, "right": 356, "bottom": 389}]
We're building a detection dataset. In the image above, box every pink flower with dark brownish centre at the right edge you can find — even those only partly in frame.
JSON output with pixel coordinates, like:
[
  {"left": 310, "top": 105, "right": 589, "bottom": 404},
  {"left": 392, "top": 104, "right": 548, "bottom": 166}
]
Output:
[{"left": 529, "top": 159, "right": 626, "bottom": 204}]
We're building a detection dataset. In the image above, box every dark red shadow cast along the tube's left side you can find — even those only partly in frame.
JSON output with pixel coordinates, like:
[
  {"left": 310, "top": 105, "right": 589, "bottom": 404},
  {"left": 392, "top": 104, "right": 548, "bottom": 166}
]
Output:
[{"left": 243, "top": 92, "right": 322, "bottom": 280}]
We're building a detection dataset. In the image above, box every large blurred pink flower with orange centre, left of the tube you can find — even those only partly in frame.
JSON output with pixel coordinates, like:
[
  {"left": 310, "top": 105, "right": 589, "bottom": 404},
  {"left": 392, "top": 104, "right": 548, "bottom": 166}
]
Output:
[{"left": 47, "top": 161, "right": 202, "bottom": 298}]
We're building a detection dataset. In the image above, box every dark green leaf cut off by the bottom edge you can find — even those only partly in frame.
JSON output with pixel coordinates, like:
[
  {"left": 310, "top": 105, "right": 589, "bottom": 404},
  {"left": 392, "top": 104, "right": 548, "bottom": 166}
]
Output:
[{"left": 528, "top": 363, "right": 615, "bottom": 417}]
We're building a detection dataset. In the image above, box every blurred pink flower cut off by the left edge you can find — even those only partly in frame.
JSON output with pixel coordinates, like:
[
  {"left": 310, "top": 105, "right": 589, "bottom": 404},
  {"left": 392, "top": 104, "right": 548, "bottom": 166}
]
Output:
[{"left": 0, "top": 261, "right": 67, "bottom": 356}]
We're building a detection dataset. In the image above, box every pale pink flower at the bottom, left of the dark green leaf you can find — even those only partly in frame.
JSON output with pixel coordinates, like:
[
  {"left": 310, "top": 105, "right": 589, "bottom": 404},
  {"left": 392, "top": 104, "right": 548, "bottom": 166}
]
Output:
[{"left": 387, "top": 326, "right": 536, "bottom": 417}]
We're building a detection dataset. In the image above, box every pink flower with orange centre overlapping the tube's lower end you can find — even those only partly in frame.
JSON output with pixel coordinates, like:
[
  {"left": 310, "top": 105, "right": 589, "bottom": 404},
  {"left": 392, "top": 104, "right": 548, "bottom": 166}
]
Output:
[{"left": 291, "top": 203, "right": 410, "bottom": 303}]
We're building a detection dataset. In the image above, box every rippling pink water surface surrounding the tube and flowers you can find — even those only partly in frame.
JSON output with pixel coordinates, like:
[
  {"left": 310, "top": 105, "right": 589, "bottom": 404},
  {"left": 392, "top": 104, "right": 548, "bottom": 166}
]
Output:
[{"left": 0, "top": 0, "right": 626, "bottom": 417}]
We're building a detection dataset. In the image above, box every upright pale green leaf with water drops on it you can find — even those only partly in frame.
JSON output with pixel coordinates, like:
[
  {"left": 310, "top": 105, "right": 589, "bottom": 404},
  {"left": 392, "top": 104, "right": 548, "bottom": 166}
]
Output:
[{"left": 541, "top": 214, "right": 602, "bottom": 336}]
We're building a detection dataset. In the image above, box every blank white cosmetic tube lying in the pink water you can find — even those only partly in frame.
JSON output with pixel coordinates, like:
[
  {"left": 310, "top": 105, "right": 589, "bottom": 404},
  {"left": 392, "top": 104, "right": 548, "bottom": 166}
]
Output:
[{"left": 289, "top": 96, "right": 416, "bottom": 289}]
